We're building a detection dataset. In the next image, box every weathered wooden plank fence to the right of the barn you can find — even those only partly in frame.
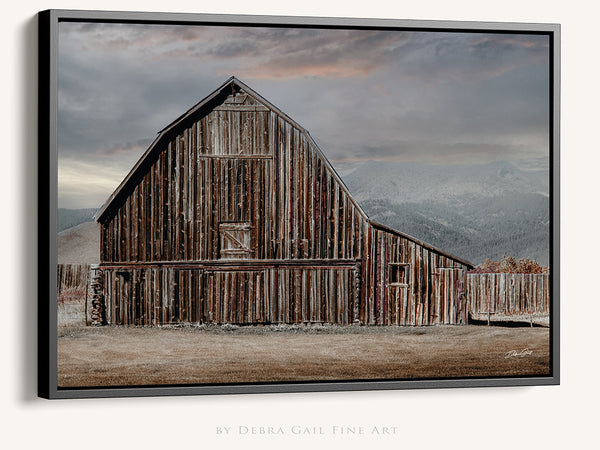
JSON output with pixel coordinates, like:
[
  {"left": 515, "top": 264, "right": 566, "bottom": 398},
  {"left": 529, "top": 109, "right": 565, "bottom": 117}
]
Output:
[{"left": 466, "top": 273, "right": 550, "bottom": 323}]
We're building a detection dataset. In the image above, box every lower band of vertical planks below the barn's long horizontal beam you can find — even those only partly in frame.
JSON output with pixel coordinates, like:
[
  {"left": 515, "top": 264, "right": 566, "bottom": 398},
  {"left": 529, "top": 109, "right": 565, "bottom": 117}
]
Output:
[{"left": 103, "top": 267, "right": 355, "bottom": 325}]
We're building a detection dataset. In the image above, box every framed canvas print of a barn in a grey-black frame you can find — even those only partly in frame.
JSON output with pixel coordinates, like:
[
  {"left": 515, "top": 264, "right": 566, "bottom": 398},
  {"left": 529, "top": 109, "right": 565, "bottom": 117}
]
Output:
[{"left": 39, "top": 10, "right": 560, "bottom": 398}]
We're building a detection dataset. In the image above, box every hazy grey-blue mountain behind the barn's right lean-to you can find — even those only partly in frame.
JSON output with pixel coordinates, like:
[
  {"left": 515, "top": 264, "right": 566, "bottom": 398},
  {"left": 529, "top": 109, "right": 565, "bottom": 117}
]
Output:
[{"left": 343, "top": 161, "right": 549, "bottom": 265}]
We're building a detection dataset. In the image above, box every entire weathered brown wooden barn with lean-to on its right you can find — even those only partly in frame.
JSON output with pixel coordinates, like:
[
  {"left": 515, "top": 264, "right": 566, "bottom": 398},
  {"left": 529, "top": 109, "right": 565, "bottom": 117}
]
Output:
[{"left": 95, "top": 77, "right": 472, "bottom": 325}]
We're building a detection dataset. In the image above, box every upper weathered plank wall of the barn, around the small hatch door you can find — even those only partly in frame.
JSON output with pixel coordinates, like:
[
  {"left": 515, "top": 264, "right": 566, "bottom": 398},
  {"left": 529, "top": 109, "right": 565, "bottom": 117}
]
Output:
[{"left": 101, "top": 93, "right": 362, "bottom": 262}]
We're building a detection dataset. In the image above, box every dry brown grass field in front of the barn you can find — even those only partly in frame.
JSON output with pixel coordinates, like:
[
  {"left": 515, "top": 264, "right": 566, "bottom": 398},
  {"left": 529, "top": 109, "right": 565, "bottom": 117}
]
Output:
[{"left": 58, "top": 326, "right": 549, "bottom": 387}]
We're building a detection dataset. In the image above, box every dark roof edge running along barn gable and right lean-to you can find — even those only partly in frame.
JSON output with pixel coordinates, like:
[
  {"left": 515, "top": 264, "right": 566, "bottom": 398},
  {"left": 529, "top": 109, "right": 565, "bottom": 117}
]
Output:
[{"left": 94, "top": 76, "right": 474, "bottom": 267}]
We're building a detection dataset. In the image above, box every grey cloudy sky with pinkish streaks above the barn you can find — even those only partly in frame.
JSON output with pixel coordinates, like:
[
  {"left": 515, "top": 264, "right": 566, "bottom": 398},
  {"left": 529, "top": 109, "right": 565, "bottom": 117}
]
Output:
[{"left": 58, "top": 22, "right": 549, "bottom": 208}]
